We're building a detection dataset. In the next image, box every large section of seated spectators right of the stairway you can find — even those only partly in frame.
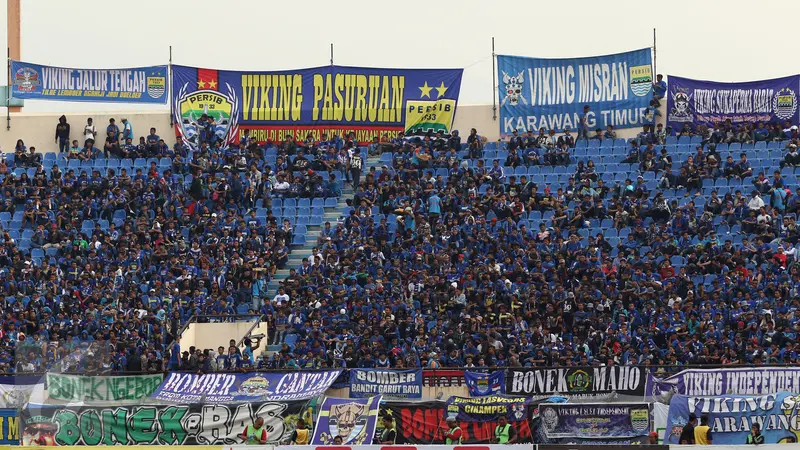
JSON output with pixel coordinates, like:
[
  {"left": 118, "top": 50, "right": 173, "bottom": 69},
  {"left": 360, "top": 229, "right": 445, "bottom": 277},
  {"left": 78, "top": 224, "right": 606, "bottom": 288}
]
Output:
[{"left": 267, "top": 118, "right": 800, "bottom": 374}]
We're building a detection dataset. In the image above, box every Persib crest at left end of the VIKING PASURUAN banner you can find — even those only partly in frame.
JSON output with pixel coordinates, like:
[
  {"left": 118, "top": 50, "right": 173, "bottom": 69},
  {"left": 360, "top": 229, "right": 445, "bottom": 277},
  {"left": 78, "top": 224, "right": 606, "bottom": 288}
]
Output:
[{"left": 174, "top": 83, "right": 239, "bottom": 149}]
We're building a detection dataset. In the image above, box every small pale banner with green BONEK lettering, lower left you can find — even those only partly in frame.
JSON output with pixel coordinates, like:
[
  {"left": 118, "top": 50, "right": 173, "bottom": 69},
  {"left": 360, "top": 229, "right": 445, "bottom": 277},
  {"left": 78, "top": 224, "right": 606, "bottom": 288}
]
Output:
[{"left": 47, "top": 373, "right": 164, "bottom": 402}]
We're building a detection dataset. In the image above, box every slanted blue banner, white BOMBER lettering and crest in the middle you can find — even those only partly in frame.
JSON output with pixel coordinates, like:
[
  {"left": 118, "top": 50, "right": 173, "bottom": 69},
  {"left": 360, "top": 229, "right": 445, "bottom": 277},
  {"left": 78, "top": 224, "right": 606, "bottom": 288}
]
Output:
[{"left": 151, "top": 370, "right": 342, "bottom": 404}]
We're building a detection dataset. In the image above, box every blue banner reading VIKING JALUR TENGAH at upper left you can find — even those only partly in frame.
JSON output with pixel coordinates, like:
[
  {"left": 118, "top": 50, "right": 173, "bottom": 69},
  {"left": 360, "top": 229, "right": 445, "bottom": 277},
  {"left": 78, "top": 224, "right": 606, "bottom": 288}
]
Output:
[{"left": 11, "top": 61, "right": 168, "bottom": 105}]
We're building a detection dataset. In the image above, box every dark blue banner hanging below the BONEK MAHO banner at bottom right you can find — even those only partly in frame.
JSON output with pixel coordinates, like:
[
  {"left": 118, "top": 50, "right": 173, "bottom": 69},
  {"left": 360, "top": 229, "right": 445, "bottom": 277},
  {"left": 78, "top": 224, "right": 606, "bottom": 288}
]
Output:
[{"left": 539, "top": 403, "right": 650, "bottom": 439}]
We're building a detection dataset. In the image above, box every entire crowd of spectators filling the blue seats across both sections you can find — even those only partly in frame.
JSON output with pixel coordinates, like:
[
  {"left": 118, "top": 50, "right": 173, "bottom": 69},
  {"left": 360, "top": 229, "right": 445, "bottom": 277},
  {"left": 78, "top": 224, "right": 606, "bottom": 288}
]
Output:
[{"left": 0, "top": 105, "right": 800, "bottom": 373}]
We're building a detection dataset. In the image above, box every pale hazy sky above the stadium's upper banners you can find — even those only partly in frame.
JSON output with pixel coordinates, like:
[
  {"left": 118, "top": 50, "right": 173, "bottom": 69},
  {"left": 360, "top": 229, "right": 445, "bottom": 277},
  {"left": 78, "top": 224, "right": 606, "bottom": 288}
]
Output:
[{"left": 6, "top": 0, "right": 800, "bottom": 112}]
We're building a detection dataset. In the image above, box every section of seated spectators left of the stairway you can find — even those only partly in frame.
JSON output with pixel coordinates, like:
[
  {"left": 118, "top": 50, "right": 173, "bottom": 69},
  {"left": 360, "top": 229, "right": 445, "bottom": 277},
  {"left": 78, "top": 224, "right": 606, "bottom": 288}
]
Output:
[{"left": 0, "top": 116, "right": 358, "bottom": 373}]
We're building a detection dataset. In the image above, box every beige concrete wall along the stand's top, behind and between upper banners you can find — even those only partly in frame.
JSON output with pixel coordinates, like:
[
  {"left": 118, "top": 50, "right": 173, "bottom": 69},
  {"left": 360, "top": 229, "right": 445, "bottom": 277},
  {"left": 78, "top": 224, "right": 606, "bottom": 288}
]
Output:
[{"left": 0, "top": 102, "right": 666, "bottom": 152}]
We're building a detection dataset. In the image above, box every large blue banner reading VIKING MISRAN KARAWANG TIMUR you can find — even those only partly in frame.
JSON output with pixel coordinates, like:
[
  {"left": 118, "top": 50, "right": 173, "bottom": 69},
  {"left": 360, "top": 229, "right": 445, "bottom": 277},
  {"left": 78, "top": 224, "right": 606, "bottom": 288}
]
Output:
[{"left": 497, "top": 48, "right": 653, "bottom": 137}]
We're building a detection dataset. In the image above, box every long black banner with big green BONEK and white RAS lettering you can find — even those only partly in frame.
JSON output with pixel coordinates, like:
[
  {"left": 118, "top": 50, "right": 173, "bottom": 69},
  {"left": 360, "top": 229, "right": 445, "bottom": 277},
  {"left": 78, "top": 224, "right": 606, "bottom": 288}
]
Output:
[{"left": 21, "top": 402, "right": 313, "bottom": 446}]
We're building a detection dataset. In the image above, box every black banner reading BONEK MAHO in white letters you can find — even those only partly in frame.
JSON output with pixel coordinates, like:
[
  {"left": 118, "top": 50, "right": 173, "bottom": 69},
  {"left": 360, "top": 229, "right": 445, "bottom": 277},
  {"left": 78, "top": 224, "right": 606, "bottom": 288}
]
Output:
[{"left": 506, "top": 366, "right": 647, "bottom": 396}]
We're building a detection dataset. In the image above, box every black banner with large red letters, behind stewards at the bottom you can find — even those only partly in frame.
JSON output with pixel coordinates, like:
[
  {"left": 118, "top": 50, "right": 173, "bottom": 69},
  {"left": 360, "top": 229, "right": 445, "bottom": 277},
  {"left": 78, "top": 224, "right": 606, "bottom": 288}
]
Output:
[{"left": 375, "top": 401, "right": 531, "bottom": 445}]
